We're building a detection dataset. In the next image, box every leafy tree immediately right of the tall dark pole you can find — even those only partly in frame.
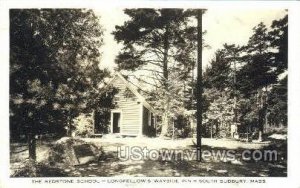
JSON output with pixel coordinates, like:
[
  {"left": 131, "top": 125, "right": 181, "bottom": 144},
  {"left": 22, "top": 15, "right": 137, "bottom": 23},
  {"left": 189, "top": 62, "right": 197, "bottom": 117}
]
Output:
[{"left": 204, "top": 44, "right": 240, "bottom": 136}]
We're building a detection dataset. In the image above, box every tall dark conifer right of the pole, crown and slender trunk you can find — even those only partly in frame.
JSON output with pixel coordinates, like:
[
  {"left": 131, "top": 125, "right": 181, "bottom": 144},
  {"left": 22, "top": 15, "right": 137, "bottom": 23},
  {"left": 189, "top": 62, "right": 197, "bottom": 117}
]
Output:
[{"left": 238, "top": 23, "right": 277, "bottom": 140}]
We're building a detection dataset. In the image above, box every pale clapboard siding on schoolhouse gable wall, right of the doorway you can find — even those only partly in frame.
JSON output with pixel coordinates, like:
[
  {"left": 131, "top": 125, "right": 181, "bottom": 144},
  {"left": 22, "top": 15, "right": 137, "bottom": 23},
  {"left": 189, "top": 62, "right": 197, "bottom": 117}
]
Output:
[{"left": 113, "top": 77, "right": 142, "bottom": 135}]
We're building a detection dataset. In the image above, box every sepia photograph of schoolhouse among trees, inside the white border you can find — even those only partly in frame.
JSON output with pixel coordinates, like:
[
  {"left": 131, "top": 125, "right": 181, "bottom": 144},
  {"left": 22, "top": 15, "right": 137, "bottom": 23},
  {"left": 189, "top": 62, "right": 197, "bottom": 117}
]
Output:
[{"left": 1, "top": 0, "right": 299, "bottom": 186}]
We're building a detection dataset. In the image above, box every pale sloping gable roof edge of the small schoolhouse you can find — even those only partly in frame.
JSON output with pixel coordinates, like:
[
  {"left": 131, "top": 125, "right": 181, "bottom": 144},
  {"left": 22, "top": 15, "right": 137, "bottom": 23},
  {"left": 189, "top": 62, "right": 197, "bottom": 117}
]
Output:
[{"left": 108, "top": 72, "right": 158, "bottom": 114}]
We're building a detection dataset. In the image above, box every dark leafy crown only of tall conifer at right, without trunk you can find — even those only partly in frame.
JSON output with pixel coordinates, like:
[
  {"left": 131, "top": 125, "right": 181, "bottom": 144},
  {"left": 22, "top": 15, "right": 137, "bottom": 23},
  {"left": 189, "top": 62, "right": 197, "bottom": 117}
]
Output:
[{"left": 237, "top": 23, "right": 277, "bottom": 96}]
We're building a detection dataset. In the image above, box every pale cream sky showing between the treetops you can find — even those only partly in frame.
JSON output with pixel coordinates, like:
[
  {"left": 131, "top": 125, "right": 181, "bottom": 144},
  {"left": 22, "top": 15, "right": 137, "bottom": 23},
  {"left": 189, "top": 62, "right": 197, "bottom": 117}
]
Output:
[{"left": 94, "top": 8, "right": 286, "bottom": 70}]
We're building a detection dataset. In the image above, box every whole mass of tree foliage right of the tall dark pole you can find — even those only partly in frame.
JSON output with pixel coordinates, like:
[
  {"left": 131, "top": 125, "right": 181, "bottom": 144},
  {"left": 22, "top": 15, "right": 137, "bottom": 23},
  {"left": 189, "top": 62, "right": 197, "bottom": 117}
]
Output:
[{"left": 203, "top": 13, "right": 287, "bottom": 136}]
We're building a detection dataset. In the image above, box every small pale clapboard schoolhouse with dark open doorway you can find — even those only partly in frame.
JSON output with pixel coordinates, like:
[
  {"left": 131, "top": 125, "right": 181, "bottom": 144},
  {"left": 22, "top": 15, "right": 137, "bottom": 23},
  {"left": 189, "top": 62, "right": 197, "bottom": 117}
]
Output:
[{"left": 110, "top": 72, "right": 157, "bottom": 136}]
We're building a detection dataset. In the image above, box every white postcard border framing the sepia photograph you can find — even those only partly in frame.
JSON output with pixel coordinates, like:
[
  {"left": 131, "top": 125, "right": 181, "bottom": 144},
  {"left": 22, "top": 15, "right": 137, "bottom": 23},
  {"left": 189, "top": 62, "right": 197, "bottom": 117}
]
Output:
[{"left": 0, "top": 0, "right": 300, "bottom": 188}]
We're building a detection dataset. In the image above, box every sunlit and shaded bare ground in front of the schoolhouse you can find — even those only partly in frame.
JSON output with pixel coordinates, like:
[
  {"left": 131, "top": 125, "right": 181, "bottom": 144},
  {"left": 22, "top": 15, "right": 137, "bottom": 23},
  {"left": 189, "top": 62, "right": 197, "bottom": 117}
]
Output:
[{"left": 11, "top": 135, "right": 287, "bottom": 177}]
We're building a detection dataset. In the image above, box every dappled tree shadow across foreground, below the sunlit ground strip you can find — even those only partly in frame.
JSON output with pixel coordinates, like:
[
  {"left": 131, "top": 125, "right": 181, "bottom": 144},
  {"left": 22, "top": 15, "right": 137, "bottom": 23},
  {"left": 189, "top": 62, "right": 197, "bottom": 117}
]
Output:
[{"left": 13, "top": 140, "right": 287, "bottom": 177}]
